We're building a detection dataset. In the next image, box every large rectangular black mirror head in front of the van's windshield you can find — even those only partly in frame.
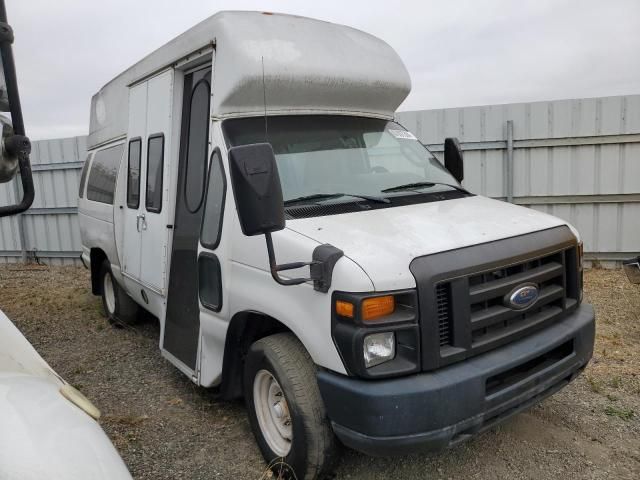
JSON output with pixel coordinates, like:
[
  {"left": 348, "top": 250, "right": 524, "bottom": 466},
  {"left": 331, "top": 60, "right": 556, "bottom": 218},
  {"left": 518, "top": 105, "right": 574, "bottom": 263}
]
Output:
[{"left": 229, "top": 143, "right": 284, "bottom": 236}]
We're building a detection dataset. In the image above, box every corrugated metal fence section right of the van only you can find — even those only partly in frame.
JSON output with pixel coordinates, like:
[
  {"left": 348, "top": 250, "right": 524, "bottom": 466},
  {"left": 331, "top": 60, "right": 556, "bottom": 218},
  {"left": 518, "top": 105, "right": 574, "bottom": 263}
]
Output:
[{"left": 397, "top": 95, "right": 640, "bottom": 261}]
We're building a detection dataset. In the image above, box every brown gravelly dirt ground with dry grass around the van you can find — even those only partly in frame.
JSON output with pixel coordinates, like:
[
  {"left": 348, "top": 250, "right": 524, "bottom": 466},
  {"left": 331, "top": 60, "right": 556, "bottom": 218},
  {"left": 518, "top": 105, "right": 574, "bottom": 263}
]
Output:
[{"left": 0, "top": 265, "right": 640, "bottom": 480}]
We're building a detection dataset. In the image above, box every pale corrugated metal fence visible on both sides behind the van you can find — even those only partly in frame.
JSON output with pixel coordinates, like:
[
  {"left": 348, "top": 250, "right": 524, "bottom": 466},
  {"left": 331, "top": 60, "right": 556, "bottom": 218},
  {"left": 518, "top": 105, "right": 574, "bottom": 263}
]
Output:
[{"left": 0, "top": 95, "right": 640, "bottom": 263}]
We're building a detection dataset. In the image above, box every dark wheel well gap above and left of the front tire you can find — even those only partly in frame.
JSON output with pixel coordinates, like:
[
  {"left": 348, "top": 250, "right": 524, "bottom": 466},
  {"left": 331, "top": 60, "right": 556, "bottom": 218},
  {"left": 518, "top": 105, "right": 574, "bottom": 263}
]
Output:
[{"left": 220, "top": 312, "right": 291, "bottom": 400}]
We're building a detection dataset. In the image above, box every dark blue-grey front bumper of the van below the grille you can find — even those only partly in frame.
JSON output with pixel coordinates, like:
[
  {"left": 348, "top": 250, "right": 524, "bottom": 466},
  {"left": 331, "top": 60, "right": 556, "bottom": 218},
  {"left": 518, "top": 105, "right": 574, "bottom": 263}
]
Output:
[{"left": 318, "top": 304, "right": 595, "bottom": 456}]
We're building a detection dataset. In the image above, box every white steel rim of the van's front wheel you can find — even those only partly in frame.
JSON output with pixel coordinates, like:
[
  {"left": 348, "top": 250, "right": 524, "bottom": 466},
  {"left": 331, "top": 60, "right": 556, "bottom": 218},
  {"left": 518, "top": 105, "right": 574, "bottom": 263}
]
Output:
[{"left": 253, "top": 370, "right": 293, "bottom": 457}]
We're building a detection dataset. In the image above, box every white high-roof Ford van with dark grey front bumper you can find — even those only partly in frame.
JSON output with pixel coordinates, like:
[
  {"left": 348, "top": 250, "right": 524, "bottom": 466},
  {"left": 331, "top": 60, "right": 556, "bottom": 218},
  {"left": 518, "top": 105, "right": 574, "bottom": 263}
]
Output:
[{"left": 79, "top": 12, "right": 594, "bottom": 478}]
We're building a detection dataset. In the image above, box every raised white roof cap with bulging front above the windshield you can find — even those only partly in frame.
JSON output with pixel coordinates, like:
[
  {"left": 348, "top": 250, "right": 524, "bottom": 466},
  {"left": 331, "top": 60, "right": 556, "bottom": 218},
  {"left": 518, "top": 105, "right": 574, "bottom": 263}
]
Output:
[{"left": 88, "top": 12, "right": 411, "bottom": 147}]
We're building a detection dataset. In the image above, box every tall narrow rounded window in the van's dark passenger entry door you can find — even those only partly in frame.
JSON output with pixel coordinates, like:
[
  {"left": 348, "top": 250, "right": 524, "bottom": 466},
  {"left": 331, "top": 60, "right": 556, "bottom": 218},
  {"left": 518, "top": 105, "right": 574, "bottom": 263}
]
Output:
[{"left": 184, "top": 79, "right": 211, "bottom": 213}]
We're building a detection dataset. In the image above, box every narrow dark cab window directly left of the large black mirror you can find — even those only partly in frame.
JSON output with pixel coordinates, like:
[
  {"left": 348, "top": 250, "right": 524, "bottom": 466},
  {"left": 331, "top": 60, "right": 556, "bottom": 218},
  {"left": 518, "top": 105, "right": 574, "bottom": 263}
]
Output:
[{"left": 200, "top": 149, "right": 227, "bottom": 250}]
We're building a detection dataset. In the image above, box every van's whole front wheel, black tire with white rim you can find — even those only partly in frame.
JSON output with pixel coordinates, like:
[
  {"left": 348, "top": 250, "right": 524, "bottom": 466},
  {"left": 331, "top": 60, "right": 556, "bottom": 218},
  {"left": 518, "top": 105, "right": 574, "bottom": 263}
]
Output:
[{"left": 244, "top": 333, "right": 338, "bottom": 480}]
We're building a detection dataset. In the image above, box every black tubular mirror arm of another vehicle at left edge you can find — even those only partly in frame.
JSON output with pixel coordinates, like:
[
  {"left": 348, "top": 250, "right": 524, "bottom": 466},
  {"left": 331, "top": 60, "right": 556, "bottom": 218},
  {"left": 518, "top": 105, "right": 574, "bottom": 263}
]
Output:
[{"left": 0, "top": 1, "right": 35, "bottom": 217}]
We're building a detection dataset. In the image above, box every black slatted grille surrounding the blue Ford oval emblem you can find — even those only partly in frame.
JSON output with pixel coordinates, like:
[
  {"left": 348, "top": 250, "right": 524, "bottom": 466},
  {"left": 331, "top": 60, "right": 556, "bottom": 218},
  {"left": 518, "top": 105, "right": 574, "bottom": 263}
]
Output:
[{"left": 435, "top": 248, "right": 578, "bottom": 365}]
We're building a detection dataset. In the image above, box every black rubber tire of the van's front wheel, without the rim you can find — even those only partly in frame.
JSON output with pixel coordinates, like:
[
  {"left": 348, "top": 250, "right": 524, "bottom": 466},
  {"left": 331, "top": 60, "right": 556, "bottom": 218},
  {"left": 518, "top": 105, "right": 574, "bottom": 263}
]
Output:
[{"left": 244, "top": 333, "right": 339, "bottom": 480}]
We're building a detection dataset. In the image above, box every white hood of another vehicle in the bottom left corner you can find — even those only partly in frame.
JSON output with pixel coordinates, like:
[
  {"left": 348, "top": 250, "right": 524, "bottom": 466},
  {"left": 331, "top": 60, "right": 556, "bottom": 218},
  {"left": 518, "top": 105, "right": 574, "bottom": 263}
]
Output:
[{"left": 0, "top": 311, "right": 131, "bottom": 480}]
